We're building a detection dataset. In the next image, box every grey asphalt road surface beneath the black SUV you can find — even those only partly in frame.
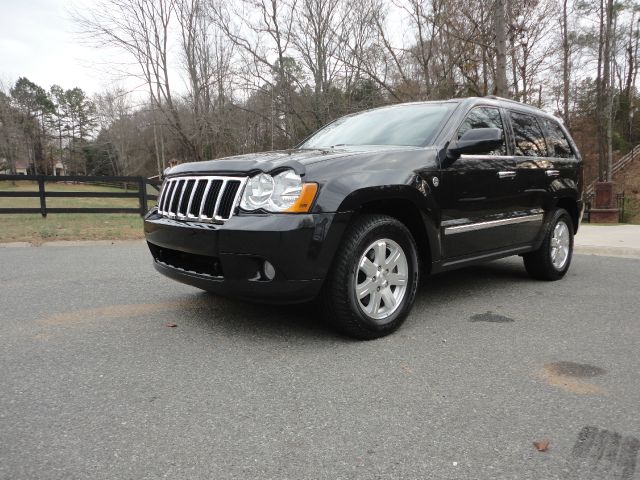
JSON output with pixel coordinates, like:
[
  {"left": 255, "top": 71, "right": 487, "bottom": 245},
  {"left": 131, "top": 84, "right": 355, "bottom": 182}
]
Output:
[{"left": 0, "top": 243, "right": 640, "bottom": 480}]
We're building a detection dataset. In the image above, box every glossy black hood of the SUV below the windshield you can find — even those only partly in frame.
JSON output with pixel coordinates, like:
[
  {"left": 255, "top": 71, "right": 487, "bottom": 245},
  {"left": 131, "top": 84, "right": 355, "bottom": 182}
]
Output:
[{"left": 165, "top": 145, "right": 424, "bottom": 176}]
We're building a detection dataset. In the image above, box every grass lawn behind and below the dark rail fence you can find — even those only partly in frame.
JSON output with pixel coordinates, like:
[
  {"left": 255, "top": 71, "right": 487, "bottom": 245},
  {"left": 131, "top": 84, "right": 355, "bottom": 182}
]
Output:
[{"left": 0, "top": 181, "right": 155, "bottom": 244}]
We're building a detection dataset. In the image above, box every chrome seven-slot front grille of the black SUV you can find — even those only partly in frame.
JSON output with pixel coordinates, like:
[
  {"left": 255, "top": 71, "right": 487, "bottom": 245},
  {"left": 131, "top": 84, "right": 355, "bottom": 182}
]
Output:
[{"left": 158, "top": 176, "right": 247, "bottom": 222}]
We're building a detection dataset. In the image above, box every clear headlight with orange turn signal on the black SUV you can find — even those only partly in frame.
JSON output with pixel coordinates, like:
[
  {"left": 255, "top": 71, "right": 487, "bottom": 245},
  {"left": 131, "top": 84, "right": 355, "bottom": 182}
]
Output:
[{"left": 240, "top": 170, "right": 318, "bottom": 212}]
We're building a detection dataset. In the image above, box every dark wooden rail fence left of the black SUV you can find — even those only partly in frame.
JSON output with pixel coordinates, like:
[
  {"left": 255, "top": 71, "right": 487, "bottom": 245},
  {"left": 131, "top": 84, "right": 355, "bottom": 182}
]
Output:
[{"left": 0, "top": 175, "right": 162, "bottom": 217}]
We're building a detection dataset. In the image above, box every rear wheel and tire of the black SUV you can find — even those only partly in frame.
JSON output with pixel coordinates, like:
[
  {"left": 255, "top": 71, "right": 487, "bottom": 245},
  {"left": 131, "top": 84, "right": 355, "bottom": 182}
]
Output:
[{"left": 523, "top": 208, "right": 573, "bottom": 280}]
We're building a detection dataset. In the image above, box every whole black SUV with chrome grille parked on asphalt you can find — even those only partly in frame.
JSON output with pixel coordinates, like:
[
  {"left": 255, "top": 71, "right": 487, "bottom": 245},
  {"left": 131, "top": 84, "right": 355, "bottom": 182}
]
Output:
[{"left": 144, "top": 97, "right": 583, "bottom": 339}]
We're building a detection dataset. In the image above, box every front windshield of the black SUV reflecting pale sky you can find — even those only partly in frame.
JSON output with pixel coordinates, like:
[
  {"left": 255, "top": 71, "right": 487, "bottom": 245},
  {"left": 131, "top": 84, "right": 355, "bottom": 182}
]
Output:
[{"left": 301, "top": 103, "right": 457, "bottom": 148}]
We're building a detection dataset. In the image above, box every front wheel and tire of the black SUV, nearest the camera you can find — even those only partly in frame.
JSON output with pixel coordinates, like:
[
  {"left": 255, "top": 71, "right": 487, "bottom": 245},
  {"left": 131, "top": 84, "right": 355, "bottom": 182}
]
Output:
[{"left": 322, "top": 215, "right": 419, "bottom": 340}]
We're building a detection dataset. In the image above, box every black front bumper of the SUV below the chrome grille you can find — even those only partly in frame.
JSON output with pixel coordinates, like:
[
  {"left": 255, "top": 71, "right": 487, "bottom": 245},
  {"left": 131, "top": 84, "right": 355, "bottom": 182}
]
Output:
[{"left": 144, "top": 209, "right": 350, "bottom": 303}]
